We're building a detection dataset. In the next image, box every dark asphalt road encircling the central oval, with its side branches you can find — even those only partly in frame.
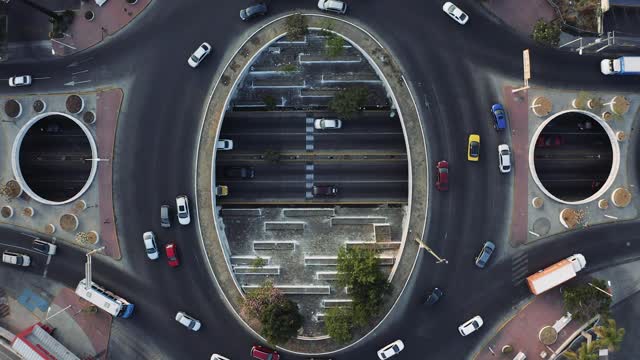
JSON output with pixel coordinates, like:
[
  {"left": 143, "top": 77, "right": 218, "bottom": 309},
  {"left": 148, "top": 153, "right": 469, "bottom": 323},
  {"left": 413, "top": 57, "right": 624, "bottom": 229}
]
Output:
[{"left": 0, "top": 0, "right": 638, "bottom": 360}]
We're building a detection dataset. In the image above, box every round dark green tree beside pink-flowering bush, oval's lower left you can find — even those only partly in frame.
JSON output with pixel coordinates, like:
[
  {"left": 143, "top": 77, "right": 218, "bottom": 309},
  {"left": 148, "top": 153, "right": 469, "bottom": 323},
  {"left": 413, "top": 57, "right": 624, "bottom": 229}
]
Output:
[{"left": 260, "top": 299, "right": 302, "bottom": 344}]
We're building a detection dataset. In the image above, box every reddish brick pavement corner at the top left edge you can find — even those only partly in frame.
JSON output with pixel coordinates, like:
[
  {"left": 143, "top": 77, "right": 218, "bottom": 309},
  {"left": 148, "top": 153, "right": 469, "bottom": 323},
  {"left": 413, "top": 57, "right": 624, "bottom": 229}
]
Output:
[{"left": 51, "top": 0, "right": 152, "bottom": 56}]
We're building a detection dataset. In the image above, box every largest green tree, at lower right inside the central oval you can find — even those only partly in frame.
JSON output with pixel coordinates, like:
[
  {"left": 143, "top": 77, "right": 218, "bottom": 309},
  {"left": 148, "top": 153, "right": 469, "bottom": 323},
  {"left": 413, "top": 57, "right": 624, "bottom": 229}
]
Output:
[{"left": 337, "top": 247, "right": 391, "bottom": 325}]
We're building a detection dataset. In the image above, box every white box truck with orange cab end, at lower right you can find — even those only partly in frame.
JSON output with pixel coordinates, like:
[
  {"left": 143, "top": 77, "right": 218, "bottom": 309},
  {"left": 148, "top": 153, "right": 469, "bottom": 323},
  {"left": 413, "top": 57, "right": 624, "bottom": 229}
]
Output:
[{"left": 527, "top": 254, "right": 587, "bottom": 295}]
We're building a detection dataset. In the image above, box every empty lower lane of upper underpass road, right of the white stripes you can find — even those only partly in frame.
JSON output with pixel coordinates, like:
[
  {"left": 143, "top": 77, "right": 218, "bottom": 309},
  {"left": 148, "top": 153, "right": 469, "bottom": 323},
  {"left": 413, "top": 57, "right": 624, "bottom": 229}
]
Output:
[{"left": 313, "top": 132, "right": 407, "bottom": 154}]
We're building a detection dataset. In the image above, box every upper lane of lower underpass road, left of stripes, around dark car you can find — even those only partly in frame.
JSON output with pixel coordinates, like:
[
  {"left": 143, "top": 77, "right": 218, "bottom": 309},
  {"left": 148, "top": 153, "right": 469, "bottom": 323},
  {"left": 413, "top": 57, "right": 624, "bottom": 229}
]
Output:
[{"left": 216, "top": 159, "right": 306, "bottom": 183}]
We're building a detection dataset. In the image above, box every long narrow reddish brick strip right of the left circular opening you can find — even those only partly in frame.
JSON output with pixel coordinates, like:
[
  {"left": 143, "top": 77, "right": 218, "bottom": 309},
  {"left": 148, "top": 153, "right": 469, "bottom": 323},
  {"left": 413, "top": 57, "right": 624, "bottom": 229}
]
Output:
[{"left": 96, "top": 89, "right": 124, "bottom": 259}]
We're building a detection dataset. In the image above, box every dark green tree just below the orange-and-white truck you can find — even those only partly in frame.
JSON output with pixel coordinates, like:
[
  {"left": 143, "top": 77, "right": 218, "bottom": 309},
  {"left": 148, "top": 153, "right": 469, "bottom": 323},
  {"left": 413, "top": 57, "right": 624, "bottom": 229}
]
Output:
[{"left": 562, "top": 279, "right": 611, "bottom": 321}]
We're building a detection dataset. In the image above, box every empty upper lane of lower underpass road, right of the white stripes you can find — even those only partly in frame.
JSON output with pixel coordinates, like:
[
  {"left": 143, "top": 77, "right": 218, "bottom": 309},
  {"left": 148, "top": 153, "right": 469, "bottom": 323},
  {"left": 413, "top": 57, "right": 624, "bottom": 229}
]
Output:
[{"left": 313, "top": 161, "right": 409, "bottom": 183}]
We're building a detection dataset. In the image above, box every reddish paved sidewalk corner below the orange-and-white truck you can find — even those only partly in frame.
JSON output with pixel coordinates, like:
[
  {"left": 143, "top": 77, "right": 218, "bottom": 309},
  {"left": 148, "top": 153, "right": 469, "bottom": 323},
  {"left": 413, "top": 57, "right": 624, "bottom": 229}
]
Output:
[{"left": 474, "top": 288, "right": 582, "bottom": 360}]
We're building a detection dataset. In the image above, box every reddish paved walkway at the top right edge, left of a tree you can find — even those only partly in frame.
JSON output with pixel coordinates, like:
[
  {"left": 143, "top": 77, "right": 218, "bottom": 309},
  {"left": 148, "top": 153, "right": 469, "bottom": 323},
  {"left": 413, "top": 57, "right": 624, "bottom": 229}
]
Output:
[{"left": 481, "top": 0, "right": 556, "bottom": 37}]
